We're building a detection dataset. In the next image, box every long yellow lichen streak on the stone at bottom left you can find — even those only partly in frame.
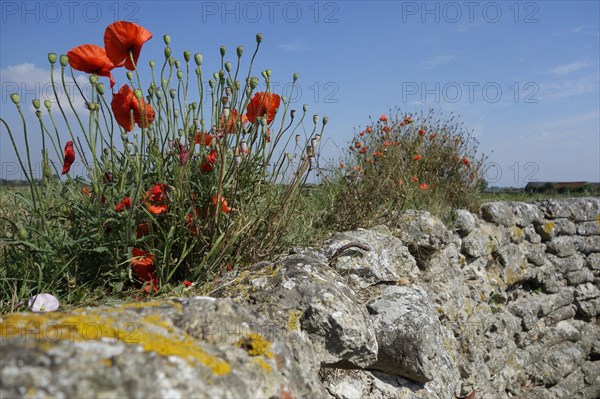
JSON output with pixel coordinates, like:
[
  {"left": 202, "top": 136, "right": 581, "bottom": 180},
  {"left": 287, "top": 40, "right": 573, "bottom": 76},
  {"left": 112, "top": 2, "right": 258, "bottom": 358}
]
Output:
[{"left": 0, "top": 309, "right": 231, "bottom": 375}]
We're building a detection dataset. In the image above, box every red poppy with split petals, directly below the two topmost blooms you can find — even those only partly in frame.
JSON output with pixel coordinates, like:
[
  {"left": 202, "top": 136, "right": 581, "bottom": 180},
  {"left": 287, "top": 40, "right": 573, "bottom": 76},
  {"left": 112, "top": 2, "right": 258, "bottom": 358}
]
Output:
[{"left": 110, "top": 85, "right": 154, "bottom": 132}]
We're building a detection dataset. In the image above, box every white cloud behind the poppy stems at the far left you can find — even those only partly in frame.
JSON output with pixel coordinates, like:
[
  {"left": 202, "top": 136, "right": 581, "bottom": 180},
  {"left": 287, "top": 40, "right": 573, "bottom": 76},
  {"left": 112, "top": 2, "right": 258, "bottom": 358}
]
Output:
[{"left": 0, "top": 63, "right": 91, "bottom": 114}]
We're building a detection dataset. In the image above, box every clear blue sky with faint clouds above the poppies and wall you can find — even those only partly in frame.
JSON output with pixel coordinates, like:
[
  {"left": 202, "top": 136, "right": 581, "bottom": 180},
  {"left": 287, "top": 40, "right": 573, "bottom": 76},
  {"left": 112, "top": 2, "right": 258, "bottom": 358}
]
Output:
[{"left": 0, "top": 1, "right": 600, "bottom": 187}]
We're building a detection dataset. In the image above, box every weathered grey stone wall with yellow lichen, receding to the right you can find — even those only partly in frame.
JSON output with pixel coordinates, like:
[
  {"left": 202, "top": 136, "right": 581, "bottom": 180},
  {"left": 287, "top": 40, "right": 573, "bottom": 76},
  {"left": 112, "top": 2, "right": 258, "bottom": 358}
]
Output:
[{"left": 0, "top": 198, "right": 600, "bottom": 399}]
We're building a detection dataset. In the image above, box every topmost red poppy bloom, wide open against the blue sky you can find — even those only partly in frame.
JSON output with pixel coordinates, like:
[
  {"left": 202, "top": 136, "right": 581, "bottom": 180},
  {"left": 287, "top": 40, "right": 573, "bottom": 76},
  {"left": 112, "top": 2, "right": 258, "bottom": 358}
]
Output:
[{"left": 104, "top": 21, "right": 152, "bottom": 71}]
